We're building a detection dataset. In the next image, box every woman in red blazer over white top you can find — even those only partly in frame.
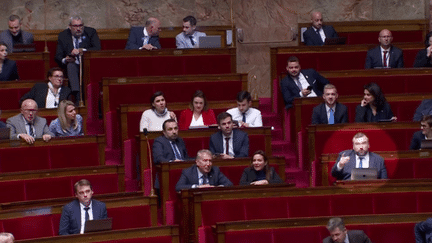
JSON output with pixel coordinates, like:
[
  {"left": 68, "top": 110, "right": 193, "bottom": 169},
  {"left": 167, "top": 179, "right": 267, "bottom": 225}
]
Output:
[{"left": 179, "top": 90, "right": 217, "bottom": 130}]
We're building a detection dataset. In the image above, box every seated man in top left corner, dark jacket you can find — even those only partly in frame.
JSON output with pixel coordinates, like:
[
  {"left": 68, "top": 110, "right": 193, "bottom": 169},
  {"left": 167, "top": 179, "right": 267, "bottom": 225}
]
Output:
[{"left": 0, "top": 15, "right": 33, "bottom": 53}]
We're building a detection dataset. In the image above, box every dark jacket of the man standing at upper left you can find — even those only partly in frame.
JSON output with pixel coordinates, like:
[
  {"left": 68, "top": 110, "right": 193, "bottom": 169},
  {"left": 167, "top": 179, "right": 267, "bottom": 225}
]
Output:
[{"left": 55, "top": 26, "right": 101, "bottom": 68}]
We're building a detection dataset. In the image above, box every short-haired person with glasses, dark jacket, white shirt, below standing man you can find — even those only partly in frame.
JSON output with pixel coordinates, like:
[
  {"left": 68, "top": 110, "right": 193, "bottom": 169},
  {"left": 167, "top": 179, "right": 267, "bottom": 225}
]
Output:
[{"left": 20, "top": 67, "right": 71, "bottom": 109}]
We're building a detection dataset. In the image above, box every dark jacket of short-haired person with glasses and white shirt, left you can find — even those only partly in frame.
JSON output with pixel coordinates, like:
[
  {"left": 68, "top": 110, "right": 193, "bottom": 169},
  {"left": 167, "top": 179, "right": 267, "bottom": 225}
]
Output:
[{"left": 20, "top": 83, "right": 71, "bottom": 108}]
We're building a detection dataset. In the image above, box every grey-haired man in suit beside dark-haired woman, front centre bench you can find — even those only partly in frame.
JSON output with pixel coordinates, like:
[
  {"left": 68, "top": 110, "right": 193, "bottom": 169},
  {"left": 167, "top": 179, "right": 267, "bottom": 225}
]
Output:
[{"left": 176, "top": 149, "right": 233, "bottom": 191}]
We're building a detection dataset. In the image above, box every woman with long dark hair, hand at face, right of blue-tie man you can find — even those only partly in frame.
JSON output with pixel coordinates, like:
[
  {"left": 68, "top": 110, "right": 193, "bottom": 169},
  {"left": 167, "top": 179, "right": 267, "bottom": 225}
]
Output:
[{"left": 355, "top": 83, "right": 397, "bottom": 122}]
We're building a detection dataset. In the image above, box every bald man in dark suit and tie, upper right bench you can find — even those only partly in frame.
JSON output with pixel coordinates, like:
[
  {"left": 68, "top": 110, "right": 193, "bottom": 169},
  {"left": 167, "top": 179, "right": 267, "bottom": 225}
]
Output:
[{"left": 365, "top": 29, "right": 404, "bottom": 69}]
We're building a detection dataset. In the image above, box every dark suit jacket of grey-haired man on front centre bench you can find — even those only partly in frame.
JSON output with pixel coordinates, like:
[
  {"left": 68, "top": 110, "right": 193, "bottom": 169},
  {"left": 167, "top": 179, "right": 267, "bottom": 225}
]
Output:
[{"left": 176, "top": 165, "right": 233, "bottom": 191}]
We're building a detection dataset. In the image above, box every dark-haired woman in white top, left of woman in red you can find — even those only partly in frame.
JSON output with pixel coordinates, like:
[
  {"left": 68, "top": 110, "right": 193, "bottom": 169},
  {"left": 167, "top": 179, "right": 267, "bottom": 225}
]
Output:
[{"left": 140, "top": 91, "right": 176, "bottom": 132}]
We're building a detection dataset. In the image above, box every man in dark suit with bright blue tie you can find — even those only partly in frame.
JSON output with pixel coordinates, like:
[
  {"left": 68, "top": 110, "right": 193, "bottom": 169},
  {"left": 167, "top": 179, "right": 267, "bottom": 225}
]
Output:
[{"left": 312, "top": 84, "right": 348, "bottom": 124}]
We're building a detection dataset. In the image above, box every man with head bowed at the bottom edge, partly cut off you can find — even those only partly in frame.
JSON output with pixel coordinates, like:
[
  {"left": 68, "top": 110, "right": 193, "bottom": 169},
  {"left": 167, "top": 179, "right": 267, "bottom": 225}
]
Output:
[{"left": 323, "top": 218, "right": 371, "bottom": 243}]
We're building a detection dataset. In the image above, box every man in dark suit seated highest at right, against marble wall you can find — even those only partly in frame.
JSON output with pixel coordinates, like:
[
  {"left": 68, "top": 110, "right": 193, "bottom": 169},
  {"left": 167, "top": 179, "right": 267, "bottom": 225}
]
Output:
[{"left": 303, "top": 11, "right": 338, "bottom": 46}]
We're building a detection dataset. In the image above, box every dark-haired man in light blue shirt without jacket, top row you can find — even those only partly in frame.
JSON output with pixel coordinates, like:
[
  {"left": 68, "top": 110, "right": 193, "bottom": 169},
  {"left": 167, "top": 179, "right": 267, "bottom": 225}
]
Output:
[{"left": 176, "top": 16, "right": 206, "bottom": 49}]
